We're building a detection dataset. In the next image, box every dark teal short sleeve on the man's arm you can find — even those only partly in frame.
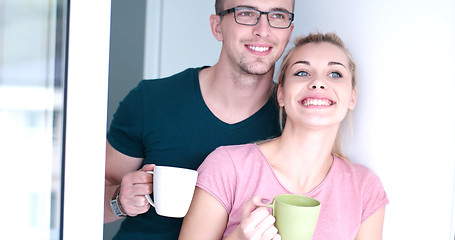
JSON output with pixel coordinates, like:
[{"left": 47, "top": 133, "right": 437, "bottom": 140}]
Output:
[{"left": 107, "top": 82, "right": 144, "bottom": 158}]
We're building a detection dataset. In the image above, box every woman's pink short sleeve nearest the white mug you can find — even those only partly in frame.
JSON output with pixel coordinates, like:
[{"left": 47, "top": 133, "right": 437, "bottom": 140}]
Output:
[{"left": 197, "top": 147, "right": 237, "bottom": 212}]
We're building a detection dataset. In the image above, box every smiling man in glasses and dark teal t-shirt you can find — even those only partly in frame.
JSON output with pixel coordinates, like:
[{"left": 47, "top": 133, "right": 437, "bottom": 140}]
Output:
[{"left": 105, "top": 0, "right": 294, "bottom": 240}]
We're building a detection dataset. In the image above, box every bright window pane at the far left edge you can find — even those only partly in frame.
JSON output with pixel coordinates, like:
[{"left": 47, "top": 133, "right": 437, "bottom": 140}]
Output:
[{"left": 0, "top": 0, "right": 67, "bottom": 239}]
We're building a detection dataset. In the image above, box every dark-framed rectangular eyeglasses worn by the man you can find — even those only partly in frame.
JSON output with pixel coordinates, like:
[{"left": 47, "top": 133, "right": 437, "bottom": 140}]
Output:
[{"left": 218, "top": 7, "right": 294, "bottom": 29}]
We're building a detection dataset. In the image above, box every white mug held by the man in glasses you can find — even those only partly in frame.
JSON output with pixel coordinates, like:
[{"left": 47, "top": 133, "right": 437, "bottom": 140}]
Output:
[{"left": 145, "top": 166, "right": 198, "bottom": 218}]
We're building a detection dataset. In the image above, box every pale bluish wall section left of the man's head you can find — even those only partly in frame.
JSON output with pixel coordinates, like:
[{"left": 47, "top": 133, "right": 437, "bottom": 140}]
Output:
[{"left": 144, "top": 0, "right": 221, "bottom": 79}]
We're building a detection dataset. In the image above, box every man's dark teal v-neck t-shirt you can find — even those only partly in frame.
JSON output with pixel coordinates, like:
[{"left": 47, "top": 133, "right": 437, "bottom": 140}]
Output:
[{"left": 107, "top": 68, "right": 280, "bottom": 240}]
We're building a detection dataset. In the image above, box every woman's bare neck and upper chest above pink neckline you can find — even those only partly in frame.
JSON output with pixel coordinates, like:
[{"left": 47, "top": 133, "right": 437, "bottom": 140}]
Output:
[{"left": 260, "top": 125, "right": 338, "bottom": 194}]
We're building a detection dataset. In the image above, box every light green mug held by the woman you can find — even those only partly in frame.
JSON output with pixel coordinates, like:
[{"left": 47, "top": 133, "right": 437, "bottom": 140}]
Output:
[{"left": 268, "top": 194, "right": 321, "bottom": 240}]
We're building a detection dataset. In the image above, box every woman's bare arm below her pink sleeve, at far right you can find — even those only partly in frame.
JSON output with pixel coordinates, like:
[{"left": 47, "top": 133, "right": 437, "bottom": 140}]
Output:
[{"left": 355, "top": 207, "right": 385, "bottom": 240}]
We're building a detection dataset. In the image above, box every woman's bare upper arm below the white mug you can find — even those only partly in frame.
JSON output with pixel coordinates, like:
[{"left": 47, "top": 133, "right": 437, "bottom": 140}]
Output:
[{"left": 179, "top": 187, "right": 228, "bottom": 240}]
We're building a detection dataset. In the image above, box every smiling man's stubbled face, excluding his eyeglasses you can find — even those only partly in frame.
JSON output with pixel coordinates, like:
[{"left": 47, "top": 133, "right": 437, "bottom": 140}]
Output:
[{"left": 219, "top": 0, "right": 294, "bottom": 75}]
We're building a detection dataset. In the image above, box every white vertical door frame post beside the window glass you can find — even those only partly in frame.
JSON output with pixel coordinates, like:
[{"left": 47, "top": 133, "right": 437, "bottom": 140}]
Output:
[{"left": 63, "top": 0, "right": 111, "bottom": 240}]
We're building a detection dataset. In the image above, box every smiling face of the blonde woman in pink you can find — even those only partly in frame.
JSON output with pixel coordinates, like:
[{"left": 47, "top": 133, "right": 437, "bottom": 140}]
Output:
[{"left": 277, "top": 43, "right": 357, "bottom": 127}]
